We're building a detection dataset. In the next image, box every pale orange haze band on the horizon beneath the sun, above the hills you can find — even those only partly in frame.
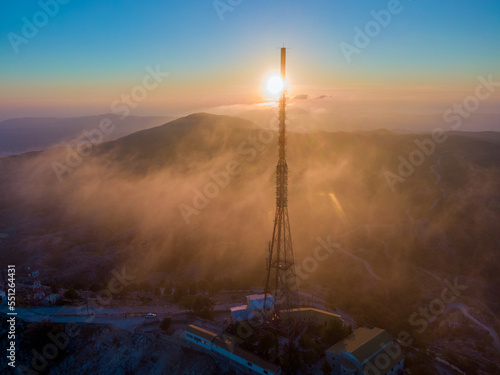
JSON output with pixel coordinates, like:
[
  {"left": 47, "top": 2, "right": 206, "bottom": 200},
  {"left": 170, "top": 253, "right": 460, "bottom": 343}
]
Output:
[{"left": 214, "top": 105, "right": 500, "bottom": 134}]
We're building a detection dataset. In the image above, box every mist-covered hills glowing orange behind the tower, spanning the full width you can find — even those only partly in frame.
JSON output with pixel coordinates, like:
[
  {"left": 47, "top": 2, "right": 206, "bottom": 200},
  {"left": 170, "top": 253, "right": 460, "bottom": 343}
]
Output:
[{"left": 0, "top": 113, "right": 500, "bottom": 372}]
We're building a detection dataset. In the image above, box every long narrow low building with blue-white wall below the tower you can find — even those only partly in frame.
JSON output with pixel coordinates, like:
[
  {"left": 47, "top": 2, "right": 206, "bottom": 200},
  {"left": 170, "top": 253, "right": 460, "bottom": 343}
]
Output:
[{"left": 185, "top": 325, "right": 281, "bottom": 375}]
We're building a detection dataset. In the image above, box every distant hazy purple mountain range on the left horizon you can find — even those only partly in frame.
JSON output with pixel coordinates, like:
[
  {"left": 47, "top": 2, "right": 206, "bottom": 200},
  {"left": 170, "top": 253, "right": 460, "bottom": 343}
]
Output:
[{"left": 0, "top": 114, "right": 173, "bottom": 157}]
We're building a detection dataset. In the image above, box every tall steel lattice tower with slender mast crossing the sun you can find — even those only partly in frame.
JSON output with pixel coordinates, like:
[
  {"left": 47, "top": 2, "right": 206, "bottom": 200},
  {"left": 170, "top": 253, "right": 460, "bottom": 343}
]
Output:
[{"left": 264, "top": 48, "right": 299, "bottom": 338}]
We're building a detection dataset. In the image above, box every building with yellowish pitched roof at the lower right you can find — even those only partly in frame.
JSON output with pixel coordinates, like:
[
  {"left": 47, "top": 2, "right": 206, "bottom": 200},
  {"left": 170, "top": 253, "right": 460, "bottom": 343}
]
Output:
[{"left": 326, "top": 328, "right": 404, "bottom": 375}]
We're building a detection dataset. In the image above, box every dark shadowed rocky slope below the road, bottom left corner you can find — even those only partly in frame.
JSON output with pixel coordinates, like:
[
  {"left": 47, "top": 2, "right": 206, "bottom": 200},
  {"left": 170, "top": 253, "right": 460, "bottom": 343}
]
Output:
[{"left": 0, "top": 315, "right": 239, "bottom": 375}]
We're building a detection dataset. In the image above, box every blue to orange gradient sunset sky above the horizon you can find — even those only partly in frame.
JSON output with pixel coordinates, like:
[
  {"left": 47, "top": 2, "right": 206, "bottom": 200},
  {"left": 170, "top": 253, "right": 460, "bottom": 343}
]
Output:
[{"left": 0, "top": 0, "right": 500, "bottom": 126}]
